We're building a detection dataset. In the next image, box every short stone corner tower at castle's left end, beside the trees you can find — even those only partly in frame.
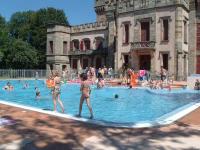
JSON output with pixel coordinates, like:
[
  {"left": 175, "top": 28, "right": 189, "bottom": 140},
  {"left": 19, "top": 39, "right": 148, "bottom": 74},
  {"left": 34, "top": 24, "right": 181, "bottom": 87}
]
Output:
[{"left": 46, "top": 25, "right": 70, "bottom": 71}]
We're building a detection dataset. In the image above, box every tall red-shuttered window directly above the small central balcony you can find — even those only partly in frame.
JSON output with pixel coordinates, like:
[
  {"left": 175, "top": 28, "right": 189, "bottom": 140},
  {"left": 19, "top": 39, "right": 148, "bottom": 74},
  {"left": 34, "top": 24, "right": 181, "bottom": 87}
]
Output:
[{"left": 141, "top": 22, "right": 150, "bottom": 41}]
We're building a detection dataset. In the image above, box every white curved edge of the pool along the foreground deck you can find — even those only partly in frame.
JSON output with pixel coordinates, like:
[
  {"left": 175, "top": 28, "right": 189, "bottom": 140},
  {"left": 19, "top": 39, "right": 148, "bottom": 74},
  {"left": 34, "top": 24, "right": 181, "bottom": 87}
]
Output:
[{"left": 0, "top": 100, "right": 200, "bottom": 128}]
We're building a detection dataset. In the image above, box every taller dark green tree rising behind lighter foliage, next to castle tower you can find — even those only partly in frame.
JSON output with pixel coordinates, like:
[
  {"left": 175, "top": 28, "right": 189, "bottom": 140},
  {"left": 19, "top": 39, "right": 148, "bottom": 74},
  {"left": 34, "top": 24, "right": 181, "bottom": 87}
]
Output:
[{"left": 9, "top": 8, "right": 69, "bottom": 69}]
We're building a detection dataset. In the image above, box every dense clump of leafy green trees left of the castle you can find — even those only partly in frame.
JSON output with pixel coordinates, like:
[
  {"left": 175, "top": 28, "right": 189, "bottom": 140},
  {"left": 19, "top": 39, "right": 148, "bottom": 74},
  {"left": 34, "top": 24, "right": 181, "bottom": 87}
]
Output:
[{"left": 0, "top": 8, "right": 69, "bottom": 69}]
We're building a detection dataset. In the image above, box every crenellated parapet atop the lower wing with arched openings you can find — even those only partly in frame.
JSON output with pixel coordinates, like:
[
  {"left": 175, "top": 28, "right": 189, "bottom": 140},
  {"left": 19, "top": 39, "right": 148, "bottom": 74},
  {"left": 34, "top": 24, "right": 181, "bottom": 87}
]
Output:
[{"left": 71, "top": 22, "right": 108, "bottom": 33}]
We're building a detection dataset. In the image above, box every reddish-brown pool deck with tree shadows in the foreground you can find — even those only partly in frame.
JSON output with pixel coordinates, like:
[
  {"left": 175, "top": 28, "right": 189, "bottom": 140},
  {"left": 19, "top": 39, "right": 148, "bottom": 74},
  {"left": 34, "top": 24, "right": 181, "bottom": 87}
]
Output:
[{"left": 0, "top": 104, "right": 200, "bottom": 150}]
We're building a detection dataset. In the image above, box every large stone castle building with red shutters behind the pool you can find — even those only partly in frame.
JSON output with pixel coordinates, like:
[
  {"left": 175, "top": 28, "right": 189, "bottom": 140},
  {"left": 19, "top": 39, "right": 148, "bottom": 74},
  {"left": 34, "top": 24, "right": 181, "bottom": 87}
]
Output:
[{"left": 47, "top": 0, "right": 200, "bottom": 79}]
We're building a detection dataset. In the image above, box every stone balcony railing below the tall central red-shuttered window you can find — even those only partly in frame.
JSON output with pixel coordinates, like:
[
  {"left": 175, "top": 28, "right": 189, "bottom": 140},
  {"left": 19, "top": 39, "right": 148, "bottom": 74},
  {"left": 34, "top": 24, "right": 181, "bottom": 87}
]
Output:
[{"left": 131, "top": 41, "right": 156, "bottom": 49}]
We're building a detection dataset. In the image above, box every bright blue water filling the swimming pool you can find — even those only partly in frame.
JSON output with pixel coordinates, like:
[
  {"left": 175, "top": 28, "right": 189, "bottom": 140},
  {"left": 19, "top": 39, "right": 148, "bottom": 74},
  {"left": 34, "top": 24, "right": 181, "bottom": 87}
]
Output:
[{"left": 0, "top": 80, "right": 200, "bottom": 123}]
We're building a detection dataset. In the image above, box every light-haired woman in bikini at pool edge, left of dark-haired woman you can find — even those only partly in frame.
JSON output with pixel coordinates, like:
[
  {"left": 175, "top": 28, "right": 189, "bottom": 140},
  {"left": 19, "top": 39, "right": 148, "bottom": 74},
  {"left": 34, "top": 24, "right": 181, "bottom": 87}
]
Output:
[{"left": 52, "top": 72, "right": 64, "bottom": 113}]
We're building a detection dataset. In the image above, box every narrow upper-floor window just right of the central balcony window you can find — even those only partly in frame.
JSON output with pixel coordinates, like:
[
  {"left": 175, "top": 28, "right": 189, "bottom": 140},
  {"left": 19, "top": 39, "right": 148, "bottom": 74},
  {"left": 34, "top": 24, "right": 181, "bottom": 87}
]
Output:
[{"left": 162, "top": 19, "right": 169, "bottom": 41}]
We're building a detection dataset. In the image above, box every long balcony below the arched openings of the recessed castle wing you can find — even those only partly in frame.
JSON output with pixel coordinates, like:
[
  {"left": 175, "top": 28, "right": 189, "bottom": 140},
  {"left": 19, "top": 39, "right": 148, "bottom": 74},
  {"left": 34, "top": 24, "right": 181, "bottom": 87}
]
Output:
[{"left": 68, "top": 48, "right": 108, "bottom": 56}]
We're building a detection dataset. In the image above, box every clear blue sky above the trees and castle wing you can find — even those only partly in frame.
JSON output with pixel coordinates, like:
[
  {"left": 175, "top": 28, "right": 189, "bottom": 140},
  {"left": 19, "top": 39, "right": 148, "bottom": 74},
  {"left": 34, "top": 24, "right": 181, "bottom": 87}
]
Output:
[{"left": 0, "top": 0, "right": 96, "bottom": 25}]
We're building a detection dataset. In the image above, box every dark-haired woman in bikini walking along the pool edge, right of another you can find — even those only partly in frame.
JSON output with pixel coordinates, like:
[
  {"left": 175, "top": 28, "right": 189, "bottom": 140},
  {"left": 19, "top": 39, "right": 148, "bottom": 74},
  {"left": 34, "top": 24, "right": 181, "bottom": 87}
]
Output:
[{"left": 78, "top": 73, "right": 93, "bottom": 119}]
